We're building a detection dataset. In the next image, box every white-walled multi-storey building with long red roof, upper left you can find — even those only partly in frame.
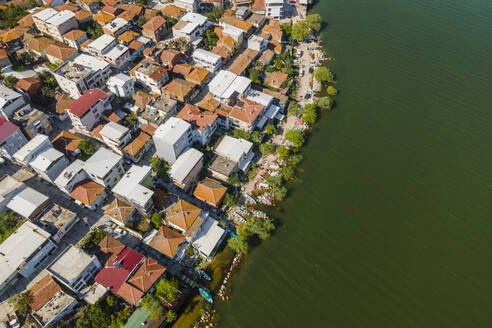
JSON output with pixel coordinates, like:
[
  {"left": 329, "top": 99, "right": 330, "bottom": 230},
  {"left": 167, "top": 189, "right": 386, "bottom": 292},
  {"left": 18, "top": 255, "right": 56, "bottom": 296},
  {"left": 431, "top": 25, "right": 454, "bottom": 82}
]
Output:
[{"left": 67, "top": 89, "right": 111, "bottom": 132}]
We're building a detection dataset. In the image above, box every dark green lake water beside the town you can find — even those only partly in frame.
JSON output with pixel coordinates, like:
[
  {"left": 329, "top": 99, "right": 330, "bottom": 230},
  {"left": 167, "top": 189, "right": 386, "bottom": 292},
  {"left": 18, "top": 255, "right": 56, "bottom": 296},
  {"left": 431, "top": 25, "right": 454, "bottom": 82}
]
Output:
[{"left": 218, "top": 0, "right": 492, "bottom": 328}]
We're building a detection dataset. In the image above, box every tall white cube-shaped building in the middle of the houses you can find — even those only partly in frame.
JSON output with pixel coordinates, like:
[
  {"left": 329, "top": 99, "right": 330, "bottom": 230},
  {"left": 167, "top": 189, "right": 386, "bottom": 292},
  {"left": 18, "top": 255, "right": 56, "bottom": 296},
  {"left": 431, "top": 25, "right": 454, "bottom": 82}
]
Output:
[{"left": 153, "top": 117, "right": 193, "bottom": 163}]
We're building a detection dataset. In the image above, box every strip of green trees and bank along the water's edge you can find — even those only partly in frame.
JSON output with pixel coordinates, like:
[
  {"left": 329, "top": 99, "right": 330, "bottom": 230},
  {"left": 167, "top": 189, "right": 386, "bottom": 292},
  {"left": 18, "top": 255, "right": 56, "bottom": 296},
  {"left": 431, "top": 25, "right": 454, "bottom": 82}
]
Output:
[{"left": 179, "top": 5, "right": 338, "bottom": 328}]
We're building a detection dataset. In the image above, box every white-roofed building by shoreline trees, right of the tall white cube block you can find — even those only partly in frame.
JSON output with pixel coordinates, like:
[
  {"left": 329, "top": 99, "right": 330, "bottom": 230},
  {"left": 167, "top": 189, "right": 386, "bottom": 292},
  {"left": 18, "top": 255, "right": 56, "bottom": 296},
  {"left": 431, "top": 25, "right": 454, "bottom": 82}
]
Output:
[{"left": 215, "top": 136, "right": 254, "bottom": 172}]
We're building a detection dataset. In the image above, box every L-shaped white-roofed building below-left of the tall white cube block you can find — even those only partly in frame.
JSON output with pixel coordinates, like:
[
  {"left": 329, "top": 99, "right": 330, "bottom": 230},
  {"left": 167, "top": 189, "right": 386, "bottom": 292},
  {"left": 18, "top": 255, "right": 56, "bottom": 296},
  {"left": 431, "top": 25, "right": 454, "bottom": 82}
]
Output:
[{"left": 112, "top": 165, "right": 154, "bottom": 215}]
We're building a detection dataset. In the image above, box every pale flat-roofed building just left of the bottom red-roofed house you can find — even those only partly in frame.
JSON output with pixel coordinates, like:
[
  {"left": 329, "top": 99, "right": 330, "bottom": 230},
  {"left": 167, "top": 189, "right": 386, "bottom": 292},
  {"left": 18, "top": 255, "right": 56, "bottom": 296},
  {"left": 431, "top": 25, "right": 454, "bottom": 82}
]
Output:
[{"left": 47, "top": 246, "right": 102, "bottom": 294}]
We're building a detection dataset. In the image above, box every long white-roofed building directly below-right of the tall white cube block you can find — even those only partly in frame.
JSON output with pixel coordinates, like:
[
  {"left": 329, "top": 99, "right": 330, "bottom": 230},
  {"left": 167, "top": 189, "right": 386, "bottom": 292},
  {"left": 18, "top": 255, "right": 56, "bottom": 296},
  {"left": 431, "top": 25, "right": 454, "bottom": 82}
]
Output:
[{"left": 169, "top": 148, "right": 203, "bottom": 191}]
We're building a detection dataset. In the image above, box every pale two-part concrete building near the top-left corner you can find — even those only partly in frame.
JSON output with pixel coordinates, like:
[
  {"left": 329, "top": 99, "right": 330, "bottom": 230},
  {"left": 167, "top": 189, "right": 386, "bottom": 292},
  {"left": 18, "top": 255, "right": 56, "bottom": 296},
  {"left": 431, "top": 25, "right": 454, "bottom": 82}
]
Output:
[{"left": 32, "top": 8, "right": 79, "bottom": 42}]
